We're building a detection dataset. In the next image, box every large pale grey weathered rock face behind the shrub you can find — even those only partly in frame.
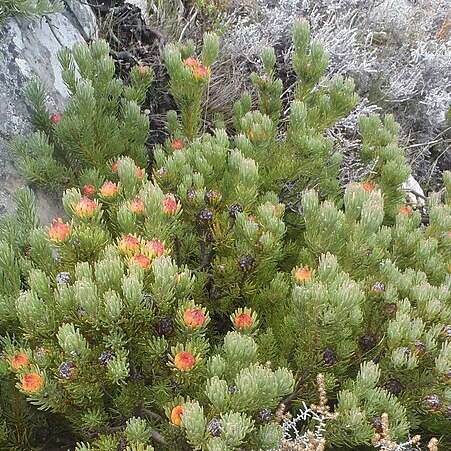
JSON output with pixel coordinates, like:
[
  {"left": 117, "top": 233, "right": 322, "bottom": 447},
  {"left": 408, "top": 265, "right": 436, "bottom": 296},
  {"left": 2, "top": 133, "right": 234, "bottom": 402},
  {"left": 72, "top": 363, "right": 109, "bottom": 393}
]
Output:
[{"left": 0, "top": 6, "right": 97, "bottom": 224}]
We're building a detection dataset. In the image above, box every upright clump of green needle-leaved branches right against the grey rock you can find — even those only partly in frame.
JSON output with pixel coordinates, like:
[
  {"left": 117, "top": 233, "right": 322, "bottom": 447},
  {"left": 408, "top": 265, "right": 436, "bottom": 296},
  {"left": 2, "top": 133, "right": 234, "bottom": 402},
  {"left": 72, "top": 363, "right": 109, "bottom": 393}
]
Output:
[{"left": 13, "top": 41, "right": 153, "bottom": 192}]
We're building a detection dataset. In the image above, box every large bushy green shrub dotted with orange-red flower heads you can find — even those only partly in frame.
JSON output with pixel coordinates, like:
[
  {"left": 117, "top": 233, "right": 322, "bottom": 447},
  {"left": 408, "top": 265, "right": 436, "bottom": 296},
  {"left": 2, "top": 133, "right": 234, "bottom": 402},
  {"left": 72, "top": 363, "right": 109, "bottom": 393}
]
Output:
[{"left": 0, "top": 18, "right": 451, "bottom": 451}]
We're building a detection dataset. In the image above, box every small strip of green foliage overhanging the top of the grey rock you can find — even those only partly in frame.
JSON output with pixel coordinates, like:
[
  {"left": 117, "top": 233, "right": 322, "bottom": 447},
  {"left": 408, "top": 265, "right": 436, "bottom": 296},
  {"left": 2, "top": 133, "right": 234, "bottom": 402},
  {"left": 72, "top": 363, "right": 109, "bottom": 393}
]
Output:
[{"left": 0, "top": 0, "right": 63, "bottom": 23}]
